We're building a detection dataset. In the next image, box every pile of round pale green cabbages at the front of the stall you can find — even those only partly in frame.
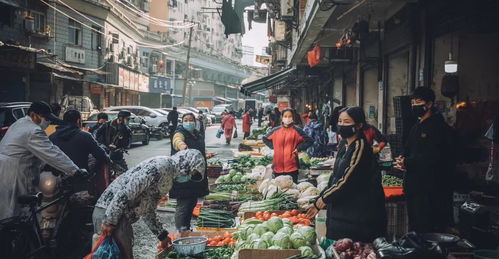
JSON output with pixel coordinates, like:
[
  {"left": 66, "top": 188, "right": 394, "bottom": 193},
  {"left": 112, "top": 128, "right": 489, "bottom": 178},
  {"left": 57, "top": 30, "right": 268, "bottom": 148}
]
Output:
[{"left": 232, "top": 217, "right": 317, "bottom": 256}]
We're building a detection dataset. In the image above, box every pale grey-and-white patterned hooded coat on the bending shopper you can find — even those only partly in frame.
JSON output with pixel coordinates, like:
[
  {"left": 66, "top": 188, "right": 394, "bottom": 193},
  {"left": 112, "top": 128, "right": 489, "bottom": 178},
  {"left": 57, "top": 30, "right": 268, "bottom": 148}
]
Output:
[{"left": 95, "top": 150, "right": 206, "bottom": 236}]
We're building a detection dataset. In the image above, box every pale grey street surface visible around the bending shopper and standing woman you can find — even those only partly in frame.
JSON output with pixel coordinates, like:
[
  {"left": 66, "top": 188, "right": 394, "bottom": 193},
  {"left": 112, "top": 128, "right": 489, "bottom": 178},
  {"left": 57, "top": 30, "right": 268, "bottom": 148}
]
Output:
[{"left": 126, "top": 120, "right": 243, "bottom": 259}]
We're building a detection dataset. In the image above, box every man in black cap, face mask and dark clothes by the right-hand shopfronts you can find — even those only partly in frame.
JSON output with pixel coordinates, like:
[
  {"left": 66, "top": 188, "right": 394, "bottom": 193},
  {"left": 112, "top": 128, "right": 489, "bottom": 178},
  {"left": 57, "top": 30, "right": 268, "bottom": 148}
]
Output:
[{"left": 395, "top": 87, "right": 456, "bottom": 233}]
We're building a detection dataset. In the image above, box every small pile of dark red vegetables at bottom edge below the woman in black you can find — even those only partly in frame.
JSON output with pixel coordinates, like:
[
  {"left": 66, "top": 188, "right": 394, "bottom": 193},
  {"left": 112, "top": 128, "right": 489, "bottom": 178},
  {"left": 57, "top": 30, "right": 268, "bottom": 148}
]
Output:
[{"left": 334, "top": 238, "right": 376, "bottom": 259}]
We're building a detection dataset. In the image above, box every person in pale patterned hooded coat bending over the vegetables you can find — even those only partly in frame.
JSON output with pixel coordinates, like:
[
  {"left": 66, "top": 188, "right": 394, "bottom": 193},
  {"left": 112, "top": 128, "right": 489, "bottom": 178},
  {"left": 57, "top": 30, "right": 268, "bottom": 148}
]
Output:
[{"left": 92, "top": 149, "right": 206, "bottom": 258}]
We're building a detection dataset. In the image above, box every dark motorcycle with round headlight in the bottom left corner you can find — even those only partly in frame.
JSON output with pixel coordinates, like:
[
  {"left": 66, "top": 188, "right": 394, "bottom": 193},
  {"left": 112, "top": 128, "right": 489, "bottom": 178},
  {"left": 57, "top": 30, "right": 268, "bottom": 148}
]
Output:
[{"left": 0, "top": 171, "right": 95, "bottom": 259}]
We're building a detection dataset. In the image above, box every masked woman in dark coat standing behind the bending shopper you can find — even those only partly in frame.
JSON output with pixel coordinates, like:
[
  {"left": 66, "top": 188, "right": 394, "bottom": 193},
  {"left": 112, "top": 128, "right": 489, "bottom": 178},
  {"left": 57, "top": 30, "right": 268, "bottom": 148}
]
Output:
[{"left": 170, "top": 113, "right": 209, "bottom": 234}]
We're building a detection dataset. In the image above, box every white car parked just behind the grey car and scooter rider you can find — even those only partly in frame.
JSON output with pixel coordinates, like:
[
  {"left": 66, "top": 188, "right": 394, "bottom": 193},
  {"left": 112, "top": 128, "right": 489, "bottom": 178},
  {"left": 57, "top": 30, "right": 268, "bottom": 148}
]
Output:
[{"left": 105, "top": 106, "right": 168, "bottom": 139}]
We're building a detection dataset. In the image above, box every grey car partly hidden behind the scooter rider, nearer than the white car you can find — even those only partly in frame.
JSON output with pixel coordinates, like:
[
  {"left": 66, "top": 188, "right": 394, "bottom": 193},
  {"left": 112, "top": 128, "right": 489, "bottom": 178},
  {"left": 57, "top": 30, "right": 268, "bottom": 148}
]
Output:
[{"left": 82, "top": 111, "right": 151, "bottom": 145}]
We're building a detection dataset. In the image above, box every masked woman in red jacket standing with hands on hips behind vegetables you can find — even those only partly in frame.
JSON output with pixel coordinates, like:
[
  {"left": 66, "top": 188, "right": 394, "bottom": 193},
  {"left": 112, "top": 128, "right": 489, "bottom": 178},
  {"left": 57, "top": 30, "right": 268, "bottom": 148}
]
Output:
[{"left": 263, "top": 108, "right": 314, "bottom": 183}]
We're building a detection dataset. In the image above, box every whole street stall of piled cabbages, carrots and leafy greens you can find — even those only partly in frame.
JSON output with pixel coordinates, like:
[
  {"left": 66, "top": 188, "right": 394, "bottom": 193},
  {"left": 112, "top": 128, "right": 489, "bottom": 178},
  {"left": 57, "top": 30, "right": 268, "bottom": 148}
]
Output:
[{"left": 158, "top": 126, "right": 484, "bottom": 259}]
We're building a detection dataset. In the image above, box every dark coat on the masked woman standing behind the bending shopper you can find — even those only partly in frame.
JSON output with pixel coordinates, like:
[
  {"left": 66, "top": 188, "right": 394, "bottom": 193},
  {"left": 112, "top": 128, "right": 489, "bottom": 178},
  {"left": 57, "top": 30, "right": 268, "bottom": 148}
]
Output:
[{"left": 170, "top": 125, "right": 210, "bottom": 199}]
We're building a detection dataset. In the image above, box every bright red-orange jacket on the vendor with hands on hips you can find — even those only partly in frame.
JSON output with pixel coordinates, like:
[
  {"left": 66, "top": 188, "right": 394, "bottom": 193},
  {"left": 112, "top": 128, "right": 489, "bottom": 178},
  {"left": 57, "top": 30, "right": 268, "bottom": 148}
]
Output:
[{"left": 263, "top": 125, "right": 314, "bottom": 173}]
